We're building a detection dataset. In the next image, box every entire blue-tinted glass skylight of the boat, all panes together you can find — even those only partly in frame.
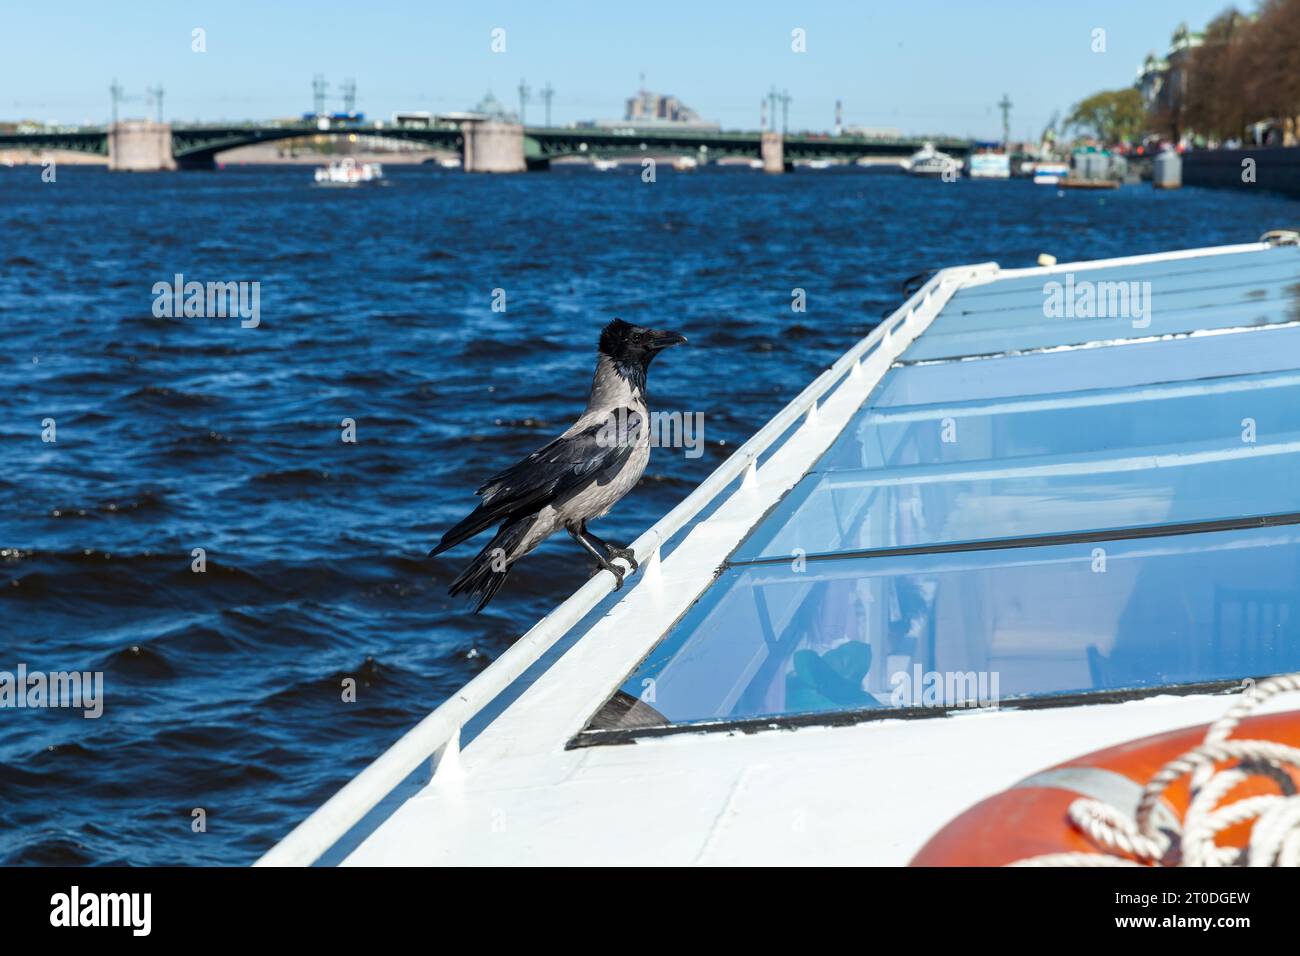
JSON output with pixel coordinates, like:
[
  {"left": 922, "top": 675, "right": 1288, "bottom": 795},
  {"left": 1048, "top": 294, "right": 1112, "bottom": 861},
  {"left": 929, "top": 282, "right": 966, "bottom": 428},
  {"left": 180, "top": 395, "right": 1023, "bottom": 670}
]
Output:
[{"left": 571, "top": 250, "right": 1300, "bottom": 745}]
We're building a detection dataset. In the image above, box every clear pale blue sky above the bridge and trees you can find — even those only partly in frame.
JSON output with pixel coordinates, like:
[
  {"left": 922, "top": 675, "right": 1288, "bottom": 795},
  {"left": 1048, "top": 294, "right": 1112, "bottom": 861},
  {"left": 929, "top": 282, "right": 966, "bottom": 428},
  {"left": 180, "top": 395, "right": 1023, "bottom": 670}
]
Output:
[{"left": 0, "top": 0, "right": 1237, "bottom": 138}]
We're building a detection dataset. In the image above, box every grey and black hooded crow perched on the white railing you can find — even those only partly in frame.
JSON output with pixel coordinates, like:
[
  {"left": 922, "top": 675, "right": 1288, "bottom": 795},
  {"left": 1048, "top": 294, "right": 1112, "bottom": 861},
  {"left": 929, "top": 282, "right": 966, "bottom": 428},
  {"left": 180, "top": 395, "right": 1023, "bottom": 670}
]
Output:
[{"left": 429, "top": 319, "right": 686, "bottom": 613}]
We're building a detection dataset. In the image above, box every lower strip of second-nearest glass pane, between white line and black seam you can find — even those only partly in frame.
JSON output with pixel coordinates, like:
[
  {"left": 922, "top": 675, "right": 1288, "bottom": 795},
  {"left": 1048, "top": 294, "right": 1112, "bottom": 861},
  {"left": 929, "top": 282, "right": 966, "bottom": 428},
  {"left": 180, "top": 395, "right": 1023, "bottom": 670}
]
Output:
[{"left": 732, "top": 447, "right": 1300, "bottom": 562}]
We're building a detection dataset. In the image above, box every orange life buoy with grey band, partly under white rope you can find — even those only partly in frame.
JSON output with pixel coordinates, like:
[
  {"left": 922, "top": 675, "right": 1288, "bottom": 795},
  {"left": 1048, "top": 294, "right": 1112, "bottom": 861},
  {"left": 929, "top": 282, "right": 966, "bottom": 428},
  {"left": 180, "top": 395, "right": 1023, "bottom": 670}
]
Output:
[{"left": 910, "top": 710, "right": 1300, "bottom": 866}]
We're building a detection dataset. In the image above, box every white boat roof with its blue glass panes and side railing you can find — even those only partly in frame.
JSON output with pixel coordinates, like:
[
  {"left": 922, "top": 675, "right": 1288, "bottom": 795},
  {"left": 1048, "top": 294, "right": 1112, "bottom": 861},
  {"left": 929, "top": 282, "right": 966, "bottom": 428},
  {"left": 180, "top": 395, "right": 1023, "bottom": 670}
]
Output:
[{"left": 260, "top": 242, "right": 1300, "bottom": 865}]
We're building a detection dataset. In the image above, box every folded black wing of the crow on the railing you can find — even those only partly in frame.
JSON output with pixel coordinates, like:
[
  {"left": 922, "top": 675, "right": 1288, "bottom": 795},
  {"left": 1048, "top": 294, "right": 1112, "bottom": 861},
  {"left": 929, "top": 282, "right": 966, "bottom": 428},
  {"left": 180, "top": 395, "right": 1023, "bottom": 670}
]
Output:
[{"left": 429, "top": 407, "right": 645, "bottom": 557}]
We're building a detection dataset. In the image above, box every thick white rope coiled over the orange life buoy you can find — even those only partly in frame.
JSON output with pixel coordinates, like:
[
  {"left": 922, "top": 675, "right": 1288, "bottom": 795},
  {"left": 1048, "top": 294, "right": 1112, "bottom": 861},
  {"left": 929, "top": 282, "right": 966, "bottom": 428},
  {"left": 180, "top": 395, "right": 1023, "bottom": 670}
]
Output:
[{"left": 1010, "top": 672, "right": 1300, "bottom": 866}]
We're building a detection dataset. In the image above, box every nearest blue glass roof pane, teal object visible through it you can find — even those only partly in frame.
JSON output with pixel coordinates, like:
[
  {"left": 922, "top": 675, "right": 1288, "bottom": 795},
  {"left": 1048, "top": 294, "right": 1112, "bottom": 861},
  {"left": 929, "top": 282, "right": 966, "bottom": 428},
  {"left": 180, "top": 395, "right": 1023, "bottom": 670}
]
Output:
[{"left": 603, "top": 527, "right": 1300, "bottom": 724}]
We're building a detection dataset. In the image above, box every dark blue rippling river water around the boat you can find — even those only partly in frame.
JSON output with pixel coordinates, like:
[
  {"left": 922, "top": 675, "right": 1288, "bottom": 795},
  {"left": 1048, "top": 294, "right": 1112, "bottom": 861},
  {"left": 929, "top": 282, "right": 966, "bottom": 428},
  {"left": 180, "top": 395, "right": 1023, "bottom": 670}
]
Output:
[{"left": 0, "top": 166, "right": 1300, "bottom": 864}]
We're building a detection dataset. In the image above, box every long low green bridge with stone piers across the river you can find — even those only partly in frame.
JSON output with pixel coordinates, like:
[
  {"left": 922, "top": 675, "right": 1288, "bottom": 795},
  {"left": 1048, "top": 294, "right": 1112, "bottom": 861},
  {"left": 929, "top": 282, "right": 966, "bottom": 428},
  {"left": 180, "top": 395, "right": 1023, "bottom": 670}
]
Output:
[{"left": 0, "top": 121, "right": 971, "bottom": 172}]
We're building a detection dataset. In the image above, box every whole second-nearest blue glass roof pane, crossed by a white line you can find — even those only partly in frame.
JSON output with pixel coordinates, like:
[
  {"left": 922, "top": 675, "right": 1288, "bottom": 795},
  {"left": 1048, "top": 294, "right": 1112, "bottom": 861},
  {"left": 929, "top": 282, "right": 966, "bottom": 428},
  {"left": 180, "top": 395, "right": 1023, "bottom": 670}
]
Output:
[{"left": 732, "top": 373, "right": 1300, "bottom": 562}]
